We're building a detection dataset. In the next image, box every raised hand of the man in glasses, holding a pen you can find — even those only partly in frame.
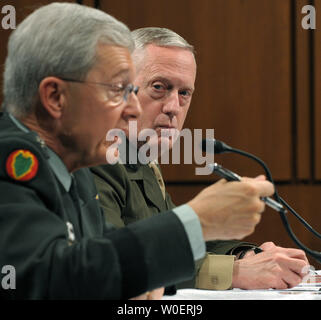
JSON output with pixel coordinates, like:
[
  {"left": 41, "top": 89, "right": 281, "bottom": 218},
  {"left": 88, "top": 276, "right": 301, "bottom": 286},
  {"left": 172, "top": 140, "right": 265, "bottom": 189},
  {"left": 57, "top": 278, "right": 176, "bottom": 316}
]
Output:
[{"left": 188, "top": 178, "right": 274, "bottom": 241}]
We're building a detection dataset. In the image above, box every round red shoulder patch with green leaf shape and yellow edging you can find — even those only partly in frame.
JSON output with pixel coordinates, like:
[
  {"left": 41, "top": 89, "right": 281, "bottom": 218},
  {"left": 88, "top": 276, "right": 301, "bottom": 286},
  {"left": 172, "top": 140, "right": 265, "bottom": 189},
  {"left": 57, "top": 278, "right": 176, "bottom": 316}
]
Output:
[{"left": 6, "top": 149, "right": 39, "bottom": 181}]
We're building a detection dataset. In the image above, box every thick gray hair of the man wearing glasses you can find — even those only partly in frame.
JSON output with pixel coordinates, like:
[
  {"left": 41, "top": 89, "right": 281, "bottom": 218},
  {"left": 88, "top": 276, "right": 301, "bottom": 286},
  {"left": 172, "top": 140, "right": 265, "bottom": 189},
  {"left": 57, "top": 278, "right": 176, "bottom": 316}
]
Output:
[{"left": 3, "top": 3, "right": 134, "bottom": 117}]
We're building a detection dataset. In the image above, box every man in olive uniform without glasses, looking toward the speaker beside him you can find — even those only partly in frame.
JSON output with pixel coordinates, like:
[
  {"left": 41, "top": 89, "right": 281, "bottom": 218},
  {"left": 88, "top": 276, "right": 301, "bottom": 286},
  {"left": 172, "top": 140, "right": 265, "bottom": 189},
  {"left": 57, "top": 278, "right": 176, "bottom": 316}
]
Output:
[{"left": 91, "top": 28, "right": 307, "bottom": 290}]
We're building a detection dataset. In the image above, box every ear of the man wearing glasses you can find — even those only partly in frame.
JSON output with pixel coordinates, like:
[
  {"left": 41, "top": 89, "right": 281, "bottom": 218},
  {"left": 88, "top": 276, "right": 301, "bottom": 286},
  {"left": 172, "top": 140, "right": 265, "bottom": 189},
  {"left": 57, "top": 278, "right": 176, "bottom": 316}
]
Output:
[{"left": 38, "top": 77, "right": 66, "bottom": 119}]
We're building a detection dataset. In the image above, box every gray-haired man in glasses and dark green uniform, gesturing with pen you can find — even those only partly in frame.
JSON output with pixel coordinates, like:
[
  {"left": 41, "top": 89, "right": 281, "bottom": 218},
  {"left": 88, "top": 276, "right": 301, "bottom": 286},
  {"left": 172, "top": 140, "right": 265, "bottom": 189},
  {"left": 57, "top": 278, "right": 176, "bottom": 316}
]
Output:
[{"left": 0, "top": 3, "right": 273, "bottom": 299}]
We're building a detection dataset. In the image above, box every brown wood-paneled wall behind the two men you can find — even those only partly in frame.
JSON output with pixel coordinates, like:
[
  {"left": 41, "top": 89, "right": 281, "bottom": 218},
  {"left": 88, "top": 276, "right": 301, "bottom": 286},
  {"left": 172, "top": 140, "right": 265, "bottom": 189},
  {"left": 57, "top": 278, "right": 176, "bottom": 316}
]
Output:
[{"left": 0, "top": 0, "right": 321, "bottom": 269}]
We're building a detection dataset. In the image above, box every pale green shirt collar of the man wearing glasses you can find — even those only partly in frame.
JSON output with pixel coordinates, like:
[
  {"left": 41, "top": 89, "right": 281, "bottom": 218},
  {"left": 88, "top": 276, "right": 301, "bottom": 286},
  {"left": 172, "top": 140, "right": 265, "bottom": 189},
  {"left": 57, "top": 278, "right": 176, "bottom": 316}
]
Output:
[{"left": 9, "top": 113, "right": 72, "bottom": 192}]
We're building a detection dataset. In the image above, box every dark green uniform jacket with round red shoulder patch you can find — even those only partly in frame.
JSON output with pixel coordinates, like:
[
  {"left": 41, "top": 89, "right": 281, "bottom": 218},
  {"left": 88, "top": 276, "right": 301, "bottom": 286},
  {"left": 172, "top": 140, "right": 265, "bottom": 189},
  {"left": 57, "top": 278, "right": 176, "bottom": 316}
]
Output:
[{"left": 0, "top": 113, "right": 194, "bottom": 299}]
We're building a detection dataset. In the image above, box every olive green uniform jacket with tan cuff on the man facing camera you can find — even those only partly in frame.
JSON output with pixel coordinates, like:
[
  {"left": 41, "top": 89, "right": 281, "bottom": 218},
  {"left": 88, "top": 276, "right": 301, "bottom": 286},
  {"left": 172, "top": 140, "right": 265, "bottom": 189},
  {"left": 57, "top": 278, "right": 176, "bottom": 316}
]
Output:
[{"left": 91, "top": 163, "right": 253, "bottom": 290}]
